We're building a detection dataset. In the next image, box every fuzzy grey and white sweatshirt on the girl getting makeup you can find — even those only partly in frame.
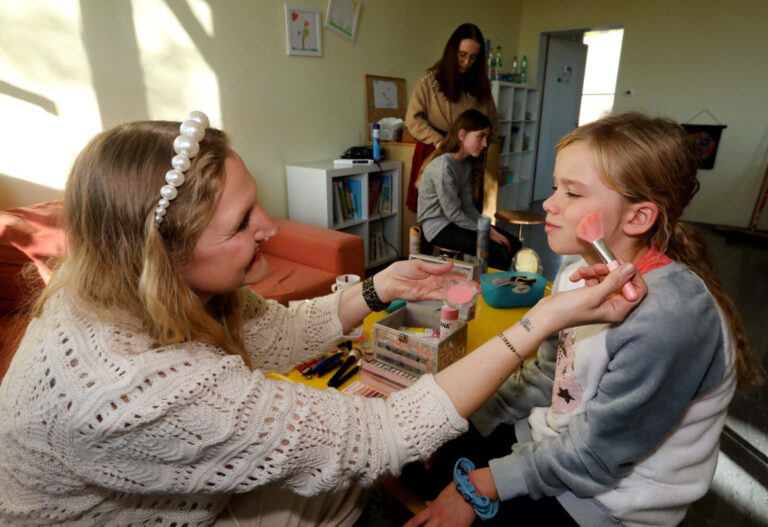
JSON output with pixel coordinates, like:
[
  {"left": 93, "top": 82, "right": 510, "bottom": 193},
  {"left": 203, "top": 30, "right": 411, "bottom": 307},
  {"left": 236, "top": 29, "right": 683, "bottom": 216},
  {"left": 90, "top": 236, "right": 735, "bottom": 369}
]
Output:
[{"left": 472, "top": 257, "right": 736, "bottom": 526}]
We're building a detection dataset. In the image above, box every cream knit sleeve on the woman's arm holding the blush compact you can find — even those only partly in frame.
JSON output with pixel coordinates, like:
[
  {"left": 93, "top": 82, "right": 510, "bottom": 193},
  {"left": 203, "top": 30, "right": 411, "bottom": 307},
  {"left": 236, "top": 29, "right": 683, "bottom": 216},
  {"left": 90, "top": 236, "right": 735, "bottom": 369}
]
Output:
[{"left": 242, "top": 289, "right": 344, "bottom": 372}]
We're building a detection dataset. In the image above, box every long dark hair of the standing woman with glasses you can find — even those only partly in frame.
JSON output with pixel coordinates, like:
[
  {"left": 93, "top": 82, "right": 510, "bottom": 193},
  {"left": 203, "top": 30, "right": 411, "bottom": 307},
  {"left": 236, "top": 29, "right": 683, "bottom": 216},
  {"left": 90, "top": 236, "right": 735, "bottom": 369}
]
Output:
[{"left": 432, "top": 23, "right": 491, "bottom": 103}]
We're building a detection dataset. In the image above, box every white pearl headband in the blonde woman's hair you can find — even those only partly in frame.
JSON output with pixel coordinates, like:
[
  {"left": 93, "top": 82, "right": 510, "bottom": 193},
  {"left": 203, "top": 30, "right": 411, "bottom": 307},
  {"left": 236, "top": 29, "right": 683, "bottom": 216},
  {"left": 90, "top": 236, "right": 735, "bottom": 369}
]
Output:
[{"left": 155, "top": 111, "right": 209, "bottom": 225}]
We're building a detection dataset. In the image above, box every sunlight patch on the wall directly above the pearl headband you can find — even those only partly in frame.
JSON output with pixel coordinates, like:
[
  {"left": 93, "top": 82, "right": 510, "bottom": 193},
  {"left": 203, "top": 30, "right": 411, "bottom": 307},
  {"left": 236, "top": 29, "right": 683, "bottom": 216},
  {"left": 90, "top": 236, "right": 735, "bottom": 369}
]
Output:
[{"left": 132, "top": 0, "right": 221, "bottom": 126}]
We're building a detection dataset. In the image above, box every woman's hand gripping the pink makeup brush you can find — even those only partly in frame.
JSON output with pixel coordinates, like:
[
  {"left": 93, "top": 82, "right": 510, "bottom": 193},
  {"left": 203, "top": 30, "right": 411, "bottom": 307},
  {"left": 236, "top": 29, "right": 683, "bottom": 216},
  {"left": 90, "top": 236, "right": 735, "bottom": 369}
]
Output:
[{"left": 528, "top": 264, "right": 648, "bottom": 332}]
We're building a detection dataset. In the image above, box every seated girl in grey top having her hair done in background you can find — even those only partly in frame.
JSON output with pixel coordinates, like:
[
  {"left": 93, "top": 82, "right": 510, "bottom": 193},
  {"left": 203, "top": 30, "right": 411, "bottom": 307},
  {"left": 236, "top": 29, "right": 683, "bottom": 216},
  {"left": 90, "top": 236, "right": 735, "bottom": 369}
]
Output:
[{"left": 417, "top": 110, "right": 521, "bottom": 270}]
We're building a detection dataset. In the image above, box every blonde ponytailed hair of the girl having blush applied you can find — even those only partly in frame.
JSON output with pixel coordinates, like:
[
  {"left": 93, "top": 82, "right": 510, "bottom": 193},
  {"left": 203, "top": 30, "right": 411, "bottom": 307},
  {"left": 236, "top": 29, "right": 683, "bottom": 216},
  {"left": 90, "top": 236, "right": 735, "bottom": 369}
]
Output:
[{"left": 555, "top": 112, "right": 762, "bottom": 388}]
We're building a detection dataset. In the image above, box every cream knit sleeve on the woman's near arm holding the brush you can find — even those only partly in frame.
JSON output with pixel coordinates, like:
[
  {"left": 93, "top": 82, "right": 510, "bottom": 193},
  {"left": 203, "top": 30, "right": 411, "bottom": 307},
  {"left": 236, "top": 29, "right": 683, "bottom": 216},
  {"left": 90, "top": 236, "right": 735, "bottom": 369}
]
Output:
[{"left": 70, "top": 346, "right": 466, "bottom": 495}]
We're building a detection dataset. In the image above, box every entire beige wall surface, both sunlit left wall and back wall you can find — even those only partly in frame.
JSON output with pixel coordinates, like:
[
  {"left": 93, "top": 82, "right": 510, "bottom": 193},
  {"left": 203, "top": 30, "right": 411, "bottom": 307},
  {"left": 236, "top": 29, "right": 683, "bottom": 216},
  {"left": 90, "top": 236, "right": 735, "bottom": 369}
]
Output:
[{"left": 0, "top": 0, "right": 768, "bottom": 226}]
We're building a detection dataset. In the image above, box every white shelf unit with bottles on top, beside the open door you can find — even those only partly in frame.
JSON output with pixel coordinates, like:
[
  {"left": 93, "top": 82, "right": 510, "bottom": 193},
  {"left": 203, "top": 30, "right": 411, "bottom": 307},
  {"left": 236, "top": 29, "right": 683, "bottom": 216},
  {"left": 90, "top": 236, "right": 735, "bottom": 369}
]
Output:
[{"left": 491, "top": 81, "right": 538, "bottom": 210}]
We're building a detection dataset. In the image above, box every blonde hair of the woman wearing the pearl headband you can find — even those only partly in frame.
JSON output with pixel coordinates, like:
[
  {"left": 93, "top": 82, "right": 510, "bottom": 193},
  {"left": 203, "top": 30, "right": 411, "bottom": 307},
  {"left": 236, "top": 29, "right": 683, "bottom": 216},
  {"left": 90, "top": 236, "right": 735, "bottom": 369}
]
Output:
[{"left": 33, "top": 121, "right": 249, "bottom": 364}]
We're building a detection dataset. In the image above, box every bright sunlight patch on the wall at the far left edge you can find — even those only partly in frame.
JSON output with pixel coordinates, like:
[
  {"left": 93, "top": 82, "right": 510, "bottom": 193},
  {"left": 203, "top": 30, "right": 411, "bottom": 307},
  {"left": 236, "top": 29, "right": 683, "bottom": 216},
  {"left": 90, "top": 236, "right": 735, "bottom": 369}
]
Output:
[{"left": 0, "top": 0, "right": 101, "bottom": 189}]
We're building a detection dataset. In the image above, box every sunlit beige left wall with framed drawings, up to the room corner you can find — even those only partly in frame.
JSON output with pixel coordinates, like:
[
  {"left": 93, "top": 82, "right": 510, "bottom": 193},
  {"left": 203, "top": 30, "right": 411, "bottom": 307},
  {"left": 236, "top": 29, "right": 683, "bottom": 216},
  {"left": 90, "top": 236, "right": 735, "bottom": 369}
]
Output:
[{"left": 0, "top": 0, "right": 520, "bottom": 217}]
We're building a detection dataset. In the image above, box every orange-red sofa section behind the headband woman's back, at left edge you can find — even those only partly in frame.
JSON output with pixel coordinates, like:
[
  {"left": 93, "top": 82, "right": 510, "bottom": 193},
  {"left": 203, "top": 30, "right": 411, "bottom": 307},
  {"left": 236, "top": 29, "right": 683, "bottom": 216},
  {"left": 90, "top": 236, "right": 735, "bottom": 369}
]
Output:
[{"left": 0, "top": 201, "right": 66, "bottom": 314}]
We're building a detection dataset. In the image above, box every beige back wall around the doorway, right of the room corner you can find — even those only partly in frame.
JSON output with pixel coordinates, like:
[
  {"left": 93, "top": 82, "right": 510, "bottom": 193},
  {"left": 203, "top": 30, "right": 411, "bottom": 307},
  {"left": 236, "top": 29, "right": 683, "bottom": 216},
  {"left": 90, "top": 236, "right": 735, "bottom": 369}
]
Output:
[{"left": 519, "top": 0, "right": 768, "bottom": 227}]
